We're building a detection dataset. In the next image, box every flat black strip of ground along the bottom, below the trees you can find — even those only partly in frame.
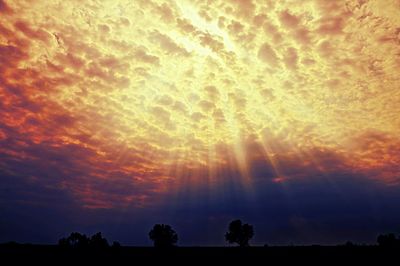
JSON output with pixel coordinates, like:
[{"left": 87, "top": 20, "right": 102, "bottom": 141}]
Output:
[{"left": 0, "top": 244, "right": 400, "bottom": 265}]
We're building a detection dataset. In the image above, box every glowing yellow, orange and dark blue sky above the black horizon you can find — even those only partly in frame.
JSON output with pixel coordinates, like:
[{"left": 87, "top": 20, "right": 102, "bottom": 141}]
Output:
[{"left": 0, "top": 0, "right": 400, "bottom": 245}]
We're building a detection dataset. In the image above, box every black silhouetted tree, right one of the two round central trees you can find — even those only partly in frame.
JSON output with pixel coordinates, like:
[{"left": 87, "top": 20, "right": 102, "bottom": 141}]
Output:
[{"left": 225, "top": 220, "right": 254, "bottom": 247}]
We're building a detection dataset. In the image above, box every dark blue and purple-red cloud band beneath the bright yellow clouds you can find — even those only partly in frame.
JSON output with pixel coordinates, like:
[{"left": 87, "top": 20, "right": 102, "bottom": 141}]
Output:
[{"left": 0, "top": 127, "right": 400, "bottom": 245}]
